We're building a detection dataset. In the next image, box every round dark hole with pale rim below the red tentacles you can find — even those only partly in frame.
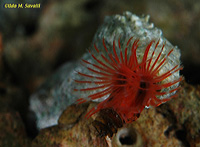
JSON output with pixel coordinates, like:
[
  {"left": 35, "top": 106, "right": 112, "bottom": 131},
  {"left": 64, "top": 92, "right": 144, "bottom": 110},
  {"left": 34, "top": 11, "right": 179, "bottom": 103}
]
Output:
[{"left": 118, "top": 128, "right": 137, "bottom": 145}]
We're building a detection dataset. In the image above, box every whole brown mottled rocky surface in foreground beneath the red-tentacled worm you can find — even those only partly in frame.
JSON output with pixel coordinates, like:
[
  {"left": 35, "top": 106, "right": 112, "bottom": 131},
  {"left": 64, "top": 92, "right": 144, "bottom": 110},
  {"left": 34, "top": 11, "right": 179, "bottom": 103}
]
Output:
[{"left": 33, "top": 82, "right": 200, "bottom": 147}]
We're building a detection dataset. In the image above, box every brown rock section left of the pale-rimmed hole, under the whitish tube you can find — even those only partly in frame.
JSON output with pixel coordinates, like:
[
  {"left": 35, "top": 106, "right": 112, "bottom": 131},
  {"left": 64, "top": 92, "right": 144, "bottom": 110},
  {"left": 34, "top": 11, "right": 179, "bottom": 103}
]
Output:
[{"left": 32, "top": 104, "right": 108, "bottom": 147}]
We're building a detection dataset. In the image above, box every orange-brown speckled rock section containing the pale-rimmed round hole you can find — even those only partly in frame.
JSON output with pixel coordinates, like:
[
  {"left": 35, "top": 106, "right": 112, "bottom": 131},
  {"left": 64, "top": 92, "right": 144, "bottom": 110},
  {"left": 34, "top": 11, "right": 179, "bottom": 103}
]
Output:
[{"left": 112, "top": 108, "right": 182, "bottom": 147}]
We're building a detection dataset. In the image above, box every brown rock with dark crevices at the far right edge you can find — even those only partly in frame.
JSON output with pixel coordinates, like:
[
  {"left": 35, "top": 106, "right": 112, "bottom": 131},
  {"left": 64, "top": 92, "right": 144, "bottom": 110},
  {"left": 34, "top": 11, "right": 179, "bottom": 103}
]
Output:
[{"left": 157, "top": 82, "right": 200, "bottom": 146}]
